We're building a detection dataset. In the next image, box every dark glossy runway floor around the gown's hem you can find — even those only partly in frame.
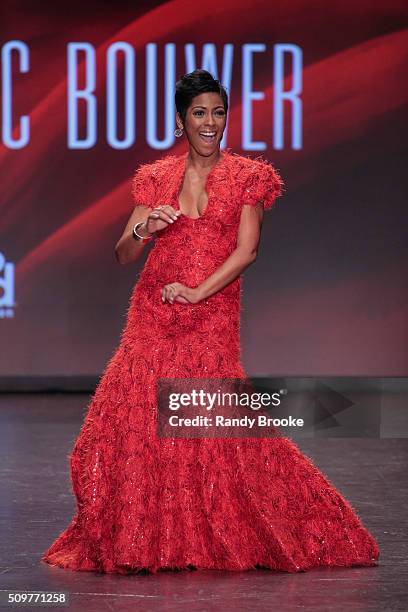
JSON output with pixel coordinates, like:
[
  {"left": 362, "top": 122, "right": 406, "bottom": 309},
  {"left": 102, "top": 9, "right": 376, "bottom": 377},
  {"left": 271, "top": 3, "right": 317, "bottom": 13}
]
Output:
[{"left": 0, "top": 394, "right": 408, "bottom": 612}]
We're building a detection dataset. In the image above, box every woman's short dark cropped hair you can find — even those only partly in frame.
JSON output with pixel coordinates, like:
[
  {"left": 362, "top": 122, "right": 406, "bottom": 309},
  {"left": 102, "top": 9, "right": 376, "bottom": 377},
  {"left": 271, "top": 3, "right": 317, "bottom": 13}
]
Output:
[{"left": 175, "top": 68, "right": 228, "bottom": 123}]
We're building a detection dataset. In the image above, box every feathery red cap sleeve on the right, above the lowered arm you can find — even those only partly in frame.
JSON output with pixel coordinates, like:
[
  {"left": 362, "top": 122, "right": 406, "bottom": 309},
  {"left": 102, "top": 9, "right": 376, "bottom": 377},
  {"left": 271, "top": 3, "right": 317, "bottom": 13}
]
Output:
[{"left": 242, "top": 159, "right": 284, "bottom": 210}]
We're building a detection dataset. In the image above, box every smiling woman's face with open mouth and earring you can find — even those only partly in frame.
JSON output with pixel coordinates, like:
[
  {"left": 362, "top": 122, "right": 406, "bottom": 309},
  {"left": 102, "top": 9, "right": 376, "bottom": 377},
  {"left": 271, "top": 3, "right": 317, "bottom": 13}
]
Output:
[{"left": 177, "top": 92, "right": 227, "bottom": 157}]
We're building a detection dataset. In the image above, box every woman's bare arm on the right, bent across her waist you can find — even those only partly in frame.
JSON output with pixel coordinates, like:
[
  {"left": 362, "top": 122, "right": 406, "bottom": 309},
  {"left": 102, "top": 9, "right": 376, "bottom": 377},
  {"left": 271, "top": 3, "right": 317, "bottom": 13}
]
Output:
[{"left": 162, "top": 202, "right": 264, "bottom": 303}]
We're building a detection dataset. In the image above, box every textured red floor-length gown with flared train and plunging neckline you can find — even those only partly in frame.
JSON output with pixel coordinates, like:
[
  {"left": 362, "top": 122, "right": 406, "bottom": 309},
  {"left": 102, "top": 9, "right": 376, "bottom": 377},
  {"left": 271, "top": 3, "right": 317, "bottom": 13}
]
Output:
[{"left": 42, "top": 150, "right": 379, "bottom": 574}]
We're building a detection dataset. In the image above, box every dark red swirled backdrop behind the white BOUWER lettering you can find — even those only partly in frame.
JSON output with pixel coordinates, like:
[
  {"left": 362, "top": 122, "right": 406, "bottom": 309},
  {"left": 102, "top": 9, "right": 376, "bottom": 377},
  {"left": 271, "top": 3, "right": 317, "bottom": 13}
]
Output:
[{"left": 0, "top": 0, "right": 408, "bottom": 376}]
